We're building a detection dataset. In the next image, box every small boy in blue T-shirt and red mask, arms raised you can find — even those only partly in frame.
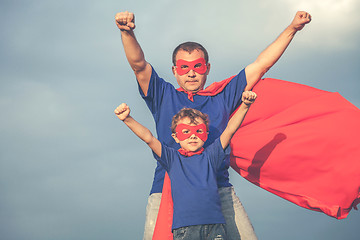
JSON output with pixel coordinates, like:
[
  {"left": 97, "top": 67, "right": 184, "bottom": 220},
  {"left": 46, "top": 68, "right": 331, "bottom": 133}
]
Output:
[{"left": 114, "top": 91, "right": 257, "bottom": 239}]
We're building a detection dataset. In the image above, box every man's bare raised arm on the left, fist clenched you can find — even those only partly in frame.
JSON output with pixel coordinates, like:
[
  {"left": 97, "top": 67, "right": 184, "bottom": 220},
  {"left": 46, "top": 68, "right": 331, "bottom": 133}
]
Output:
[{"left": 115, "top": 11, "right": 152, "bottom": 95}]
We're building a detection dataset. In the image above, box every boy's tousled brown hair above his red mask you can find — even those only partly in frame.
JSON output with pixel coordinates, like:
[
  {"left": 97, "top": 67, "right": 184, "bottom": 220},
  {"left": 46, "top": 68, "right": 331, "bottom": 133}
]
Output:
[{"left": 171, "top": 108, "right": 209, "bottom": 133}]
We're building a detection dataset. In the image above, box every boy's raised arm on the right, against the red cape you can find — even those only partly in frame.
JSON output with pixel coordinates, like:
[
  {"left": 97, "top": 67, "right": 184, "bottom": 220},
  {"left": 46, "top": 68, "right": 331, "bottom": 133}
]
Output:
[{"left": 220, "top": 91, "right": 257, "bottom": 149}]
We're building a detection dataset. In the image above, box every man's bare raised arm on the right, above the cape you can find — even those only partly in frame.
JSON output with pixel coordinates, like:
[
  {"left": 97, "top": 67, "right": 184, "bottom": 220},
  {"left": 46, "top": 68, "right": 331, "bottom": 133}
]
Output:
[{"left": 245, "top": 11, "right": 311, "bottom": 90}]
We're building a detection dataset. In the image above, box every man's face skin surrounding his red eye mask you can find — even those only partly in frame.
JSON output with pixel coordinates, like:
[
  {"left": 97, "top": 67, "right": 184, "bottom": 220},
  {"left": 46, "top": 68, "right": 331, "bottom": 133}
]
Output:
[{"left": 172, "top": 50, "right": 210, "bottom": 93}]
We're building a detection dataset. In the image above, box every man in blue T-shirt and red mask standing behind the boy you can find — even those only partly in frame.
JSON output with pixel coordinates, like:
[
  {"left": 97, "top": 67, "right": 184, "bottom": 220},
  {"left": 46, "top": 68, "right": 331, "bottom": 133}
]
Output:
[{"left": 115, "top": 11, "right": 311, "bottom": 239}]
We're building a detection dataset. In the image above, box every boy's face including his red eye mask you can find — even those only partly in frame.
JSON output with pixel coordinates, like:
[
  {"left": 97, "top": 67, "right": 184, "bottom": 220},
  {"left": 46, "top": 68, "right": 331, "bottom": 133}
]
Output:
[{"left": 172, "top": 117, "right": 207, "bottom": 152}]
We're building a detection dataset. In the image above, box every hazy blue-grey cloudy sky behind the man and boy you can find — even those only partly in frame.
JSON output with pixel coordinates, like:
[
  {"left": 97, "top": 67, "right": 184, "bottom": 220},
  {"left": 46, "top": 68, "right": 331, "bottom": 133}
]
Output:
[{"left": 0, "top": 0, "right": 360, "bottom": 240}]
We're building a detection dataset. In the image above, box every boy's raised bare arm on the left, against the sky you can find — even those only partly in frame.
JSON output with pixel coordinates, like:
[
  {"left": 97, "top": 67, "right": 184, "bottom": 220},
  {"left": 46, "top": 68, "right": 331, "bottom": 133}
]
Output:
[{"left": 114, "top": 103, "right": 161, "bottom": 157}]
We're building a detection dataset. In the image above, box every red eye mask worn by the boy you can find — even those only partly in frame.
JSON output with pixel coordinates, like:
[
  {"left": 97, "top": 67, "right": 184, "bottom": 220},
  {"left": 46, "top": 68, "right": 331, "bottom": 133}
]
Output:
[{"left": 175, "top": 123, "right": 208, "bottom": 142}]
